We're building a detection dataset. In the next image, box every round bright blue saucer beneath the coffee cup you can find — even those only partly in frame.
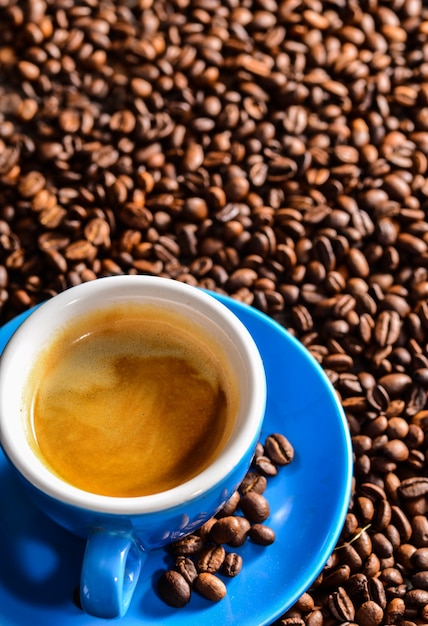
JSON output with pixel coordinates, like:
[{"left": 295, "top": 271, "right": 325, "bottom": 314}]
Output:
[{"left": 0, "top": 294, "right": 352, "bottom": 626}]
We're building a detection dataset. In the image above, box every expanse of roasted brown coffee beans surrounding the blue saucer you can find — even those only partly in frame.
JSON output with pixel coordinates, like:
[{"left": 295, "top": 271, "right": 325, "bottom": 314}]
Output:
[{"left": 0, "top": 0, "right": 428, "bottom": 626}]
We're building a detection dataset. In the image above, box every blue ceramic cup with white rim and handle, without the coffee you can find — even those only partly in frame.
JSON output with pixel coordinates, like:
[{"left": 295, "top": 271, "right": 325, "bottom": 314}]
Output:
[{"left": 0, "top": 276, "right": 266, "bottom": 618}]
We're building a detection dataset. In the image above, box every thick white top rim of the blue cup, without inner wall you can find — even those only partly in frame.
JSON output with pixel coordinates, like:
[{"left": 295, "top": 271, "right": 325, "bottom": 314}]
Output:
[{"left": 0, "top": 275, "right": 266, "bottom": 515}]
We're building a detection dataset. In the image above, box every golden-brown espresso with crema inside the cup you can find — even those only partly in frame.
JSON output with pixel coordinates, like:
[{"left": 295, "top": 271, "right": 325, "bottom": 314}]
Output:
[{"left": 25, "top": 304, "right": 239, "bottom": 497}]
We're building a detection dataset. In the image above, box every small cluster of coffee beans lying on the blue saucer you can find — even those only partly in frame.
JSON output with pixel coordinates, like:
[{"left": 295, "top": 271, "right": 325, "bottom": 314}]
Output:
[{"left": 158, "top": 433, "right": 294, "bottom": 608}]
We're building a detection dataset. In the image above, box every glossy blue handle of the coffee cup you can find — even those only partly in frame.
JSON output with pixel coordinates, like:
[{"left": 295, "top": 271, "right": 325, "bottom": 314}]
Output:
[{"left": 80, "top": 529, "right": 145, "bottom": 619}]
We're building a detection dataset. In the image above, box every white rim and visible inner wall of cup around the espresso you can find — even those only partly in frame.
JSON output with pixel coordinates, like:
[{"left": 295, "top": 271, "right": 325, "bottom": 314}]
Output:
[{"left": 0, "top": 276, "right": 266, "bottom": 515}]
